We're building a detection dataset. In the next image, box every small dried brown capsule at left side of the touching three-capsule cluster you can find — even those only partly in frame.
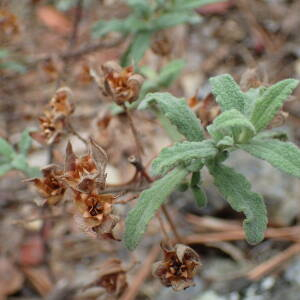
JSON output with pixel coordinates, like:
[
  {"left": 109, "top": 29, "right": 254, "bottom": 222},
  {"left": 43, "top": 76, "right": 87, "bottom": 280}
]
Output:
[{"left": 27, "top": 164, "right": 66, "bottom": 205}]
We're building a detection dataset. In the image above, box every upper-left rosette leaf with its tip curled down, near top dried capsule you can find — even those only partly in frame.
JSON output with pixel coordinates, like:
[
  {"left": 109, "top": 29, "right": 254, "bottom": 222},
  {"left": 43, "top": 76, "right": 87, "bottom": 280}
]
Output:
[{"left": 138, "top": 93, "right": 204, "bottom": 141}]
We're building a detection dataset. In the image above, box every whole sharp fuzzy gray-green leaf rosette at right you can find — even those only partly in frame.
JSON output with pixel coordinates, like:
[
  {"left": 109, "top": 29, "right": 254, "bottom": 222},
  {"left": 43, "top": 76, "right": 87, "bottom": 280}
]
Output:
[{"left": 125, "top": 75, "right": 300, "bottom": 249}]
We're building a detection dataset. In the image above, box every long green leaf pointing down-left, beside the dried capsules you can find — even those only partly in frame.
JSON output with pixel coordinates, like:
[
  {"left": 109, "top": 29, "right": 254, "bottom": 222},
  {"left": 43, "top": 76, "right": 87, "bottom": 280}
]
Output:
[{"left": 124, "top": 168, "right": 188, "bottom": 250}]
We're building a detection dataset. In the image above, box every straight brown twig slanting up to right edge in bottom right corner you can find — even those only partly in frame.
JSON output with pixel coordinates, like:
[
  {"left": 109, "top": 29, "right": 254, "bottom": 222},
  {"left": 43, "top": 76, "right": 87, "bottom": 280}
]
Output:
[{"left": 247, "top": 243, "right": 300, "bottom": 280}]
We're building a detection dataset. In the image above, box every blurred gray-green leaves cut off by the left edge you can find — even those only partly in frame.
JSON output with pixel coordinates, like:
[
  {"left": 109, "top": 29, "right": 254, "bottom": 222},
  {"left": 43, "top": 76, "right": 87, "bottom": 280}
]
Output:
[{"left": 0, "top": 130, "right": 40, "bottom": 177}]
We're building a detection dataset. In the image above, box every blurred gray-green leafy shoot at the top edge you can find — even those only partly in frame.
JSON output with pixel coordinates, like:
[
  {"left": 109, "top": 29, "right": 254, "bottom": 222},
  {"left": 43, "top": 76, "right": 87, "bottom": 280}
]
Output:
[{"left": 92, "top": 0, "right": 221, "bottom": 66}]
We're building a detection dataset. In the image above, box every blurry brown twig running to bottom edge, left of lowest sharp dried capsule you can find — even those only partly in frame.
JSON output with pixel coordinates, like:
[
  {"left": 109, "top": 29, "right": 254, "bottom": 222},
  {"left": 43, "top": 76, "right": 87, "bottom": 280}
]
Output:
[{"left": 121, "top": 245, "right": 160, "bottom": 300}]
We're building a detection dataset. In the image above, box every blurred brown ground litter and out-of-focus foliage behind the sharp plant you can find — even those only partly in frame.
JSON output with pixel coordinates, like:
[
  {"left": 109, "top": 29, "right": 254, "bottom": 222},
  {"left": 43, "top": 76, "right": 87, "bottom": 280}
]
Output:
[{"left": 0, "top": 0, "right": 300, "bottom": 300}]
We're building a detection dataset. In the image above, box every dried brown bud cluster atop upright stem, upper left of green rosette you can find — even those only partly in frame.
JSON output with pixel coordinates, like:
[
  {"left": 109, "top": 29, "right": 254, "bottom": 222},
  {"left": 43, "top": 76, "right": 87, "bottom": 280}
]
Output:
[{"left": 100, "top": 61, "right": 144, "bottom": 105}]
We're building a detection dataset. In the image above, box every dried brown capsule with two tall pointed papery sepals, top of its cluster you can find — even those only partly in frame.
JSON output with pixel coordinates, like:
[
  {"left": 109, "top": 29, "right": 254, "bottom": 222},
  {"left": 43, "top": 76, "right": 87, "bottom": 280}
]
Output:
[{"left": 64, "top": 139, "right": 107, "bottom": 193}]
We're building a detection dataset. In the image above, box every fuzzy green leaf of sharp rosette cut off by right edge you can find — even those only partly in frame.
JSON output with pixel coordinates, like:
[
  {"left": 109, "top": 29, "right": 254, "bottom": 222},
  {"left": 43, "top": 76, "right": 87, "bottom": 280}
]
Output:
[{"left": 239, "top": 138, "right": 300, "bottom": 178}]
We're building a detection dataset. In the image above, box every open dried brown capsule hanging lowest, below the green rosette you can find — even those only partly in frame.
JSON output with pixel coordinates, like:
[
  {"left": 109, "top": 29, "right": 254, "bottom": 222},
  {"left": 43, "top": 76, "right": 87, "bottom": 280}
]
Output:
[{"left": 152, "top": 244, "right": 201, "bottom": 291}]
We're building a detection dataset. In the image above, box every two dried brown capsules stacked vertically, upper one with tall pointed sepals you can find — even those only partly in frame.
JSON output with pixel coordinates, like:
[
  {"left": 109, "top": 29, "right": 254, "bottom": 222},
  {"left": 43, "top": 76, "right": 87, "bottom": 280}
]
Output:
[{"left": 63, "top": 139, "right": 119, "bottom": 239}]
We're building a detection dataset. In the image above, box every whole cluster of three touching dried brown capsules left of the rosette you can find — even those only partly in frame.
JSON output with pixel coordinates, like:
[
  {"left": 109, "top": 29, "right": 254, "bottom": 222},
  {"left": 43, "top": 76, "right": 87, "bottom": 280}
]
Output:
[{"left": 28, "top": 139, "right": 119, "bottom": 240}]
